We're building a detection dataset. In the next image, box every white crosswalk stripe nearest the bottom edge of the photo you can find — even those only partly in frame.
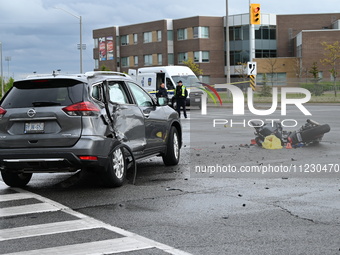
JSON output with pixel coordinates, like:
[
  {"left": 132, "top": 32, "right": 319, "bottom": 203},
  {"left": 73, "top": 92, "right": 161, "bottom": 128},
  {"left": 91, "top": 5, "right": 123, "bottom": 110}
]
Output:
[{"left": 3, "top": 237, "right": 154, "bottom": 255}]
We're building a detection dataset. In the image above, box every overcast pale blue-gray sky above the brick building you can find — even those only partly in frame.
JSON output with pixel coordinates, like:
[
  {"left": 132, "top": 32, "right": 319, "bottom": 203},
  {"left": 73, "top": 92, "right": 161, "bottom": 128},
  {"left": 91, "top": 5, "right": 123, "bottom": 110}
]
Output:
[{"left": 0, "top": 0, "right": 340, "bottom": 79}]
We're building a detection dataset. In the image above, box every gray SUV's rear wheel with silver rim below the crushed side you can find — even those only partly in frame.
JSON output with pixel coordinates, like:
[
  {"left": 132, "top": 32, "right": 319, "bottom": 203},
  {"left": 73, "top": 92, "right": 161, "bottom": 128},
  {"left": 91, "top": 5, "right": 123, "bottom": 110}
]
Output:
[{"left": 103, "top": 147, "right": 127, "bottom": 188}]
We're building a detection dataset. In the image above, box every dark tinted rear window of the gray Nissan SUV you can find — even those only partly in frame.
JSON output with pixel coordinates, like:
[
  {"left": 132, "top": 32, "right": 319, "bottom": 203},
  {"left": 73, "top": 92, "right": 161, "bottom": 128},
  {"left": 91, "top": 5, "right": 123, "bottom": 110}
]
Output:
[{"left": 1, "top": 79, "right": 84, "bottom": 109}]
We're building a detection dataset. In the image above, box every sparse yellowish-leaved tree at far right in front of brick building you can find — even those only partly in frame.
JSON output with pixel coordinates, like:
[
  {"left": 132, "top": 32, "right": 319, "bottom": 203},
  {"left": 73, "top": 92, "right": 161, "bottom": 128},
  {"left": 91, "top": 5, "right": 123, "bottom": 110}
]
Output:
[{"left": 321, "top": 41, "right": 340, "bottom": 96}]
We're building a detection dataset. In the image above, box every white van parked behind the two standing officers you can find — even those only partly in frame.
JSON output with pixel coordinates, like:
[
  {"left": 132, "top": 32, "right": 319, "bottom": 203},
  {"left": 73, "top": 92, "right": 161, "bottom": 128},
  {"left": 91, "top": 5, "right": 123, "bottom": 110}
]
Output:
[{"left": 129, "top": 66, "right": 203, "bottom": 107}]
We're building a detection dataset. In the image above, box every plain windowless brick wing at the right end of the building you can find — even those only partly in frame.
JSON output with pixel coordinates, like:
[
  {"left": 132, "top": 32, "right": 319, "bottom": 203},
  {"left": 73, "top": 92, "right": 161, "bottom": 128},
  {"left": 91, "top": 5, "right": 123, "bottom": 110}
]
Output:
[{"left": 277, "top": 13, "right": 340, "bottom": 80}]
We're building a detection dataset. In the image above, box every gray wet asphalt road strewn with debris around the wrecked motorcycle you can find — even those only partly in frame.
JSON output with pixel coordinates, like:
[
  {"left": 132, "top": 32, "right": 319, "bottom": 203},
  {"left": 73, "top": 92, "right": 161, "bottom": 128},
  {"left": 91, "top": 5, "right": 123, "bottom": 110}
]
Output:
[{"left": 2, "top": 105, "right": 340, "bottom": 255}]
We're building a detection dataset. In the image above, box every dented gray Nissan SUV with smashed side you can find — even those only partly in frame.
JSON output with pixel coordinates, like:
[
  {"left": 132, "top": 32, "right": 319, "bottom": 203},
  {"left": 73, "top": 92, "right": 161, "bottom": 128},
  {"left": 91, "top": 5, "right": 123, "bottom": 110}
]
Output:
[{"left": 0, "top": 72, "right": 182, "bottom": 187}]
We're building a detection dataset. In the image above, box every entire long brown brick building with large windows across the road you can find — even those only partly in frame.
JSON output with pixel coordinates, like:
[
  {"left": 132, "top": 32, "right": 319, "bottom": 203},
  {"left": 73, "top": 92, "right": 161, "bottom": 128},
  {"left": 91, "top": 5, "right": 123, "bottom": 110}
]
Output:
[{"left": 93, "top": 13, "right": 340, "bottom": 85}]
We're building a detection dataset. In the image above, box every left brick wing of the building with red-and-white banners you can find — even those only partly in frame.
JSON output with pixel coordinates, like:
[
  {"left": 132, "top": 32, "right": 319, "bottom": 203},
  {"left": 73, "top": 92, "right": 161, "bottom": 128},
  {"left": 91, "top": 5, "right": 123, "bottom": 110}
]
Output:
[{"left": 93, "top": 16, "right": 225, "bottom": 83}]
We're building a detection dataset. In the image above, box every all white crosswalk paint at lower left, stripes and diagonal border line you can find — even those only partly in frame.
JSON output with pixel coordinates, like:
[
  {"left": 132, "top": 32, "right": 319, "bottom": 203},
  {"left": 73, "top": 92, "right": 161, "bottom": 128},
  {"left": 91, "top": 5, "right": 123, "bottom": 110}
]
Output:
[{"left": 0, "top": 181, "right": 190, "bottom": 255}]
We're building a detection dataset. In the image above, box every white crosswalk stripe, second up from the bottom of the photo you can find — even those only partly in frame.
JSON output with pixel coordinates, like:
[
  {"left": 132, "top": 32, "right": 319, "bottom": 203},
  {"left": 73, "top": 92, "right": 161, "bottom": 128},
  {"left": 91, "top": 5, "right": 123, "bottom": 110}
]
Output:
[{"left": 0, "top": 220, "right": 98, "bottom": 241}]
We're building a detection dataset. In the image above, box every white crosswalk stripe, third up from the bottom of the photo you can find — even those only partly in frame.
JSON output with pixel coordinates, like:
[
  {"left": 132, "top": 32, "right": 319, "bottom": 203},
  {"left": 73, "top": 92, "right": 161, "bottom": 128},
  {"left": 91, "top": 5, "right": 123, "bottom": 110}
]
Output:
[{"left": 0, "top": 203, "right": 59, "bottom": 217}]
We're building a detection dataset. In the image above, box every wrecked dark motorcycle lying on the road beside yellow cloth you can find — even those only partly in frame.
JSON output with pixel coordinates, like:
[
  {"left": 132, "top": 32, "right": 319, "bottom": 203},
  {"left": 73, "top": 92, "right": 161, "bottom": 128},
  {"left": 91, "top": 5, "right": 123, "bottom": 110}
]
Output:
[{"left": 251, "top": 119, "right": 331, "bottom": 148}]
